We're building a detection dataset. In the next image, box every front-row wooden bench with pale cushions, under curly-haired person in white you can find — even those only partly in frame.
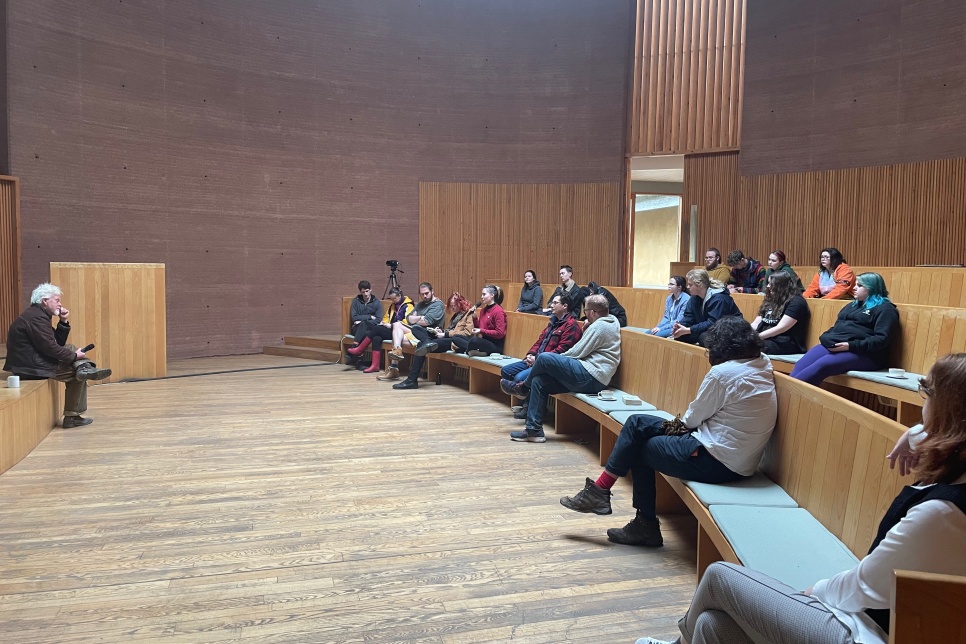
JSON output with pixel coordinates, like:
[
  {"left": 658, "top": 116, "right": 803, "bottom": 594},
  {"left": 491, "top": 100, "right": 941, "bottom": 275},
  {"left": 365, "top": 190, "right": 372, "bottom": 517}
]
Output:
[{"left": 544, "top": 331, "right": 966, "bottom": 642}]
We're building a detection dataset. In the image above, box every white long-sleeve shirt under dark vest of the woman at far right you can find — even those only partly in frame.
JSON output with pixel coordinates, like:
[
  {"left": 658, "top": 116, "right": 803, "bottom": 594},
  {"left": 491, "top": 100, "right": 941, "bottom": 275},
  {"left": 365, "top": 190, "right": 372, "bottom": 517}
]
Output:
[{"left": 812, "top": 426, "right": 966, "bottom": 644}]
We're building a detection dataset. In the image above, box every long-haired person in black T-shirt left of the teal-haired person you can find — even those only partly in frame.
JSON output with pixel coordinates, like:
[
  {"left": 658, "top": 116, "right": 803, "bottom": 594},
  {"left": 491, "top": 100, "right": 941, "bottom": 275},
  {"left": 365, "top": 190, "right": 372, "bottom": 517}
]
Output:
[{"left": 751, "top": 271, "right": 811, "bottom": 355}]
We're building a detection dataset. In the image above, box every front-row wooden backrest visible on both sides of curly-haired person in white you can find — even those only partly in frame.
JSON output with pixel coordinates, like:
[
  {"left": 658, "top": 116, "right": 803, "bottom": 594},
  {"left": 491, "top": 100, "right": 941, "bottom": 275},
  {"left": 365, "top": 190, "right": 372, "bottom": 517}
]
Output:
[{"left": 615, "top": 330, "right": 910, "bottom": 557}]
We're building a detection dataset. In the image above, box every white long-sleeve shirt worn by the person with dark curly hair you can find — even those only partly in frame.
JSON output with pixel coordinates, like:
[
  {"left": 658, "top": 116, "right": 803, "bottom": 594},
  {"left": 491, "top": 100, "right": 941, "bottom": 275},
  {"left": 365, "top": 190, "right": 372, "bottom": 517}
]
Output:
[{"left": 681, "top": 354, "right": 778, "bottom": 476}]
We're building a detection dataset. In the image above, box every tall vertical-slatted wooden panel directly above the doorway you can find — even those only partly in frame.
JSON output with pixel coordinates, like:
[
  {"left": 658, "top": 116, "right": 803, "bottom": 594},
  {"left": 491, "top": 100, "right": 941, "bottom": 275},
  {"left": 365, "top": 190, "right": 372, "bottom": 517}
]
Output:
[{"left": 630, "top": 0, "right": 745, "bottom": 155}]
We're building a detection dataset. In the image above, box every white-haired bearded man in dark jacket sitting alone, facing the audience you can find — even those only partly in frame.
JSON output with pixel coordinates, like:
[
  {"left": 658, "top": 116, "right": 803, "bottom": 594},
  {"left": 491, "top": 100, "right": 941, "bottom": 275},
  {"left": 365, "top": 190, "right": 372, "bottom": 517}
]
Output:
[{"left": 3, "top": 282, "right": 111, "bottom": 429}]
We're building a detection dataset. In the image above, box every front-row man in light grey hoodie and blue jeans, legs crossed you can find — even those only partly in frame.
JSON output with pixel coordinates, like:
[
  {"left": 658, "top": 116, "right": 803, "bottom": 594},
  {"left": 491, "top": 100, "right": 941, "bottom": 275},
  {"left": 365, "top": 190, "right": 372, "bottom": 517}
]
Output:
[{"left": 500, "top": 295, "right": 621, "bottom": 443}]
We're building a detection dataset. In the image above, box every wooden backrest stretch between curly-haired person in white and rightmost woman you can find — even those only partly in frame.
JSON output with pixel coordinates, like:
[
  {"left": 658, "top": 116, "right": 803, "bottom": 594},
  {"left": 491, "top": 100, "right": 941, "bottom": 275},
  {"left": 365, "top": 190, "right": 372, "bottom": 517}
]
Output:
[{"left": 761, "top": 373, "right": 911, "bottom": 557}]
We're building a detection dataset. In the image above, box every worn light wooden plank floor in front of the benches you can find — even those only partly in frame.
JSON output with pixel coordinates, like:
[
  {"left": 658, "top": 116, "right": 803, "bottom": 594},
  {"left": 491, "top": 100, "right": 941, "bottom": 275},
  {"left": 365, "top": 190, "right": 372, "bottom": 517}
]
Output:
[{"left": 0, "top": 356, "right": 695, "bottom": 643}]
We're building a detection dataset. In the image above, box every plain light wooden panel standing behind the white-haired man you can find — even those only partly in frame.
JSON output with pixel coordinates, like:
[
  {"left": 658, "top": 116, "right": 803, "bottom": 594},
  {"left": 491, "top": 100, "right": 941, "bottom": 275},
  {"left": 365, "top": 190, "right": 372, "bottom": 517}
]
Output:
[{"left": 50, "top": 262, "right": 167, "bottom": 382}]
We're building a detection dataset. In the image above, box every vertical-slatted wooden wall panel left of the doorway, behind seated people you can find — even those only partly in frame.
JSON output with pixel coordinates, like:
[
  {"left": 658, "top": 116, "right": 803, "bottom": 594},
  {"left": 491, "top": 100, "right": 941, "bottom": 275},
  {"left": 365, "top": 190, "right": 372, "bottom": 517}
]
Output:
[{"left": 422, "top": 183, "right": 622, "bottom": 310}]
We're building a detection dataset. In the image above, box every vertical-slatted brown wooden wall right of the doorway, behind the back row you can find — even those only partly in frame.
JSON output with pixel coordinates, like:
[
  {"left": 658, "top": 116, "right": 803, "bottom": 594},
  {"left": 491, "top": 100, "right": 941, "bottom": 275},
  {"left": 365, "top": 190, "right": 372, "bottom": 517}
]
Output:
[{"left": 681, "top": 152, "right": 966, "bottom": 266}]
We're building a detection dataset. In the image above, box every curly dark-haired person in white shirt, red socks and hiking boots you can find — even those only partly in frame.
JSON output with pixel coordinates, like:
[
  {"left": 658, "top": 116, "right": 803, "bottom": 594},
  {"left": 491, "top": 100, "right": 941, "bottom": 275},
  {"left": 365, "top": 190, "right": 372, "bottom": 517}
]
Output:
[{"left": 560, "top": 317, "right": 778, "bottom": 547}]
